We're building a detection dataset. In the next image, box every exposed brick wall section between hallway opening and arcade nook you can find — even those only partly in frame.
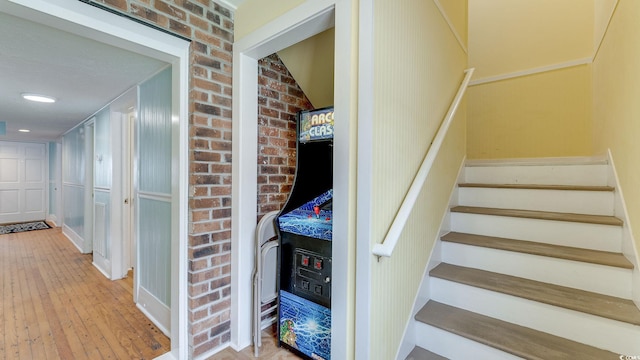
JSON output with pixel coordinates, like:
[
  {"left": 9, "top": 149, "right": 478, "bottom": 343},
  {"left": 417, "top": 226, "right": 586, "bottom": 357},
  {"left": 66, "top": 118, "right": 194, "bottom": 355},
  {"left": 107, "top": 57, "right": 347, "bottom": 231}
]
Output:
[{"left": 89, "top": 0, "right": 233, "bottom": 357}]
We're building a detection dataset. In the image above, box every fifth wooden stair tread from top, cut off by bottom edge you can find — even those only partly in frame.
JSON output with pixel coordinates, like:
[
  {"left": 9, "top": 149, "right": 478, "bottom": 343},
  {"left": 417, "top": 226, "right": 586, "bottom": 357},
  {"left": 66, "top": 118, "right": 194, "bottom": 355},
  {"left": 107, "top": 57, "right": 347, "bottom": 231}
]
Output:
[{"left": 415, "top": 301, "right": 619, "bottom": 360}]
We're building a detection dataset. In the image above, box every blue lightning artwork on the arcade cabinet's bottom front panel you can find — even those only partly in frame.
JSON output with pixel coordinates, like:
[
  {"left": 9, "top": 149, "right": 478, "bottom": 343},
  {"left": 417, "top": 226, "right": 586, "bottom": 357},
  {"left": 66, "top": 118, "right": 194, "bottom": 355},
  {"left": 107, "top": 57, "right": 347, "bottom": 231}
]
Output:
[{"left": 279, "top": 291, "right": 331, "bottom": 360}]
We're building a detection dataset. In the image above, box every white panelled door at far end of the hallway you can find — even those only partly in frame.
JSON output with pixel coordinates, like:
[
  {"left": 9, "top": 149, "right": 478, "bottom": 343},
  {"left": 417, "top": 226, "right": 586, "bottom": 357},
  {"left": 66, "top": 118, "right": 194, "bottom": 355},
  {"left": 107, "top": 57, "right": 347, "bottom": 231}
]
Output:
[{"left": 0, "top": 141, "right": 47, "bottom": 224}]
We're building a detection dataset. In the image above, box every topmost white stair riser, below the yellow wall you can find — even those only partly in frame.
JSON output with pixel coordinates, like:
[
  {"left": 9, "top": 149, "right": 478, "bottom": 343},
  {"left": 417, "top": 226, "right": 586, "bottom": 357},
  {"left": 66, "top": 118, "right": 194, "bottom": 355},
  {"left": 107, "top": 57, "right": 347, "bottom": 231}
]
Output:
[{"left": 464, "top": 165, "right": 607, "bottom": 186}]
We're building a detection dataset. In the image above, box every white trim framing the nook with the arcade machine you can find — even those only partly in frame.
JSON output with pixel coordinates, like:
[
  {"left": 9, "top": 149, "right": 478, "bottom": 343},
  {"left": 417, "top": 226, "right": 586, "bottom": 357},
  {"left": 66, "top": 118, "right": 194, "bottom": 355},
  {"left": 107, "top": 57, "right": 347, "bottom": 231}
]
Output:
[{"left": 231, "top": 0, "right": 355, "bottom": 358}]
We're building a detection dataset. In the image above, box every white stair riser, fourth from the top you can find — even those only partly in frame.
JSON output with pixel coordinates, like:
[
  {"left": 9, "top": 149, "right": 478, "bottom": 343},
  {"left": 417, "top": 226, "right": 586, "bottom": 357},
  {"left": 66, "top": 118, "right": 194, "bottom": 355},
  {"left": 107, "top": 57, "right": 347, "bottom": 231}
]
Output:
[{"left": 442, "top": 241, "right": 633, "bottom": 300}]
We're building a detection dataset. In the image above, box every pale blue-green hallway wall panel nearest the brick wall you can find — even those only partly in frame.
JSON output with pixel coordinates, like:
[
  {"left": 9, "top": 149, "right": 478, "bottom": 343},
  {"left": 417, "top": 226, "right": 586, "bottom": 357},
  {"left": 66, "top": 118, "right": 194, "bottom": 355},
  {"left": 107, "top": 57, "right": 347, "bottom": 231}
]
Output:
[{"left": 134, "top": 68, "right": 171, "bottom": 334}]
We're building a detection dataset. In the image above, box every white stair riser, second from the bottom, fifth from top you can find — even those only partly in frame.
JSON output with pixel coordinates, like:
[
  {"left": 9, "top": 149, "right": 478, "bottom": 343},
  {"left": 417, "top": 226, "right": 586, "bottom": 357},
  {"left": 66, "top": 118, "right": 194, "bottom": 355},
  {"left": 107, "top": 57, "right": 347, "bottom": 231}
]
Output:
[{"left": 430, "top": 278, "right": 640, "bottom": 354}]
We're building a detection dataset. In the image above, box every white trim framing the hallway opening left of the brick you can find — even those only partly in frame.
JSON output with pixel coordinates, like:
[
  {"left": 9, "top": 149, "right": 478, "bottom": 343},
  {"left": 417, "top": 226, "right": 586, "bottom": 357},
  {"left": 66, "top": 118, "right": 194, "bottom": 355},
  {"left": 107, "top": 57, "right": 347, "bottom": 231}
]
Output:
[{"left": 0, "top": 0, "right": 189, "bottom": 359}]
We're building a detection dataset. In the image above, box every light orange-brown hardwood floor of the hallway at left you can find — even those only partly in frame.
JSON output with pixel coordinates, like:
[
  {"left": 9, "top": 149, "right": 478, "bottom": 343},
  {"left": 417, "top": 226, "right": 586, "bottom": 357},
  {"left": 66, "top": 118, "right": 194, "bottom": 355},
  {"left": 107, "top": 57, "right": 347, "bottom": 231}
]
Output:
[{"left": 0, "top": 228, "right": 170, "bottom": 360}]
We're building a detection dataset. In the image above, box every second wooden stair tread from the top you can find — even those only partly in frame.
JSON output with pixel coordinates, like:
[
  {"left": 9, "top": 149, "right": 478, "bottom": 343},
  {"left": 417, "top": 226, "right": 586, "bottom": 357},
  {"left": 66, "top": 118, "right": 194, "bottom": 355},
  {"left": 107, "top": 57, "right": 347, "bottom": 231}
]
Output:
[{"left": 451, "top": 206, "right": 623, "bottom": 226}]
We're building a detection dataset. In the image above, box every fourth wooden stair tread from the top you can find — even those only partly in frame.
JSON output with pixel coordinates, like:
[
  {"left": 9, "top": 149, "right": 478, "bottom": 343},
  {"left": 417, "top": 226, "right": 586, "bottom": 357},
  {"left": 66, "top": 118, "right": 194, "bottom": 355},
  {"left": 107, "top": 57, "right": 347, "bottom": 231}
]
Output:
[{"left": 429, "top": 263, "right": 640, "bottom": 325}]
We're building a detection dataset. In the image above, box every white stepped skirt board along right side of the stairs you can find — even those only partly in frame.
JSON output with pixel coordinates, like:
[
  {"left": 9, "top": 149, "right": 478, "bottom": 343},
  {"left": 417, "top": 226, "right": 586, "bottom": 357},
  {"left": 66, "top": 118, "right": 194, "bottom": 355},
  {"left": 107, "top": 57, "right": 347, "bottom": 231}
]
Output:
[{"left": 607, "top": 149, "right": 640, "bottom": 309}]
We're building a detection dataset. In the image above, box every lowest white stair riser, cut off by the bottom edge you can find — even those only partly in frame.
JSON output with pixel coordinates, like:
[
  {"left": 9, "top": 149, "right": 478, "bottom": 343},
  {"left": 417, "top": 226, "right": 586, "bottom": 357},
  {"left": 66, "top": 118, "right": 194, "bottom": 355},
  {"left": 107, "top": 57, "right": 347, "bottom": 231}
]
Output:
[{"left": 415, "top": 322, "right": 521, "bottom": 360}]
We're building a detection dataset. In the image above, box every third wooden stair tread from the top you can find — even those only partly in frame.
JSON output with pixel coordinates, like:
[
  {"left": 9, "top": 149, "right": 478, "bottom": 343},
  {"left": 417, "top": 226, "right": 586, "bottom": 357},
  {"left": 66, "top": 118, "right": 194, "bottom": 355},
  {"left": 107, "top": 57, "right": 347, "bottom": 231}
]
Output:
[{"left": 441, "top": 232, "right": 633, "bottom": 269}]
